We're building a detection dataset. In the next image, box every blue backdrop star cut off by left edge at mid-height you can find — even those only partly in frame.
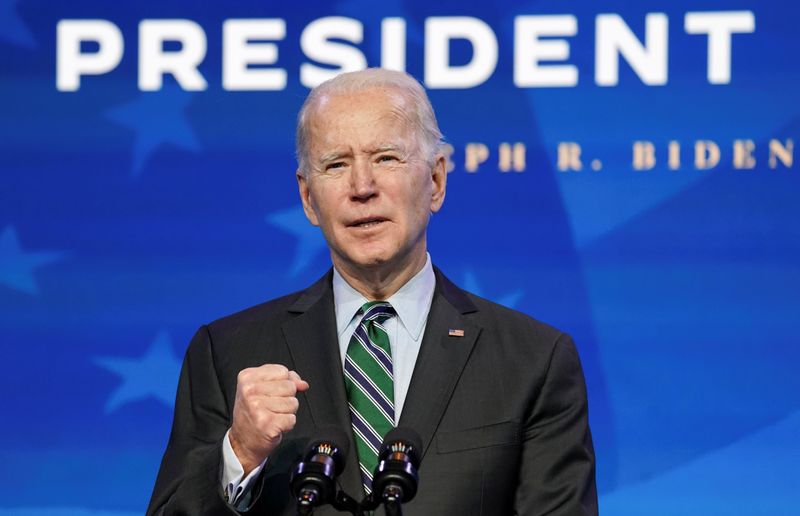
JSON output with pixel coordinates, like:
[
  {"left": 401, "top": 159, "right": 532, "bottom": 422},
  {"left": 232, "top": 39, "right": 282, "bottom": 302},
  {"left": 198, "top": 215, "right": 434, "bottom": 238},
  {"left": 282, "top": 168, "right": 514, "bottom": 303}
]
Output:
[{"left": 0, "top": 226, "right": 64, "bottom": 296}]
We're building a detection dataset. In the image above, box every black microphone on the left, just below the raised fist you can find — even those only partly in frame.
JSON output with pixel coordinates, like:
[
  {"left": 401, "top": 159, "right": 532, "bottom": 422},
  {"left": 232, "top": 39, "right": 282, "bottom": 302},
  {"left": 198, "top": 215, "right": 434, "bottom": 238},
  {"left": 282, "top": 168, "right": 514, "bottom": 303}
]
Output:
[{"left": 289, "top": 425, "right": 350, "bottom": 514}]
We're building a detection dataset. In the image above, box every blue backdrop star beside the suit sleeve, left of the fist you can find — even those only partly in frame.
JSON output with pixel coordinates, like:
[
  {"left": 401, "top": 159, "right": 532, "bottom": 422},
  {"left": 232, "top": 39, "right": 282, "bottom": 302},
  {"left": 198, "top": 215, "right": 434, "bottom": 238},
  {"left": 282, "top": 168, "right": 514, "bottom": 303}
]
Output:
[{"left": 94, "top": 331, "right": 181, "bottom": 414}]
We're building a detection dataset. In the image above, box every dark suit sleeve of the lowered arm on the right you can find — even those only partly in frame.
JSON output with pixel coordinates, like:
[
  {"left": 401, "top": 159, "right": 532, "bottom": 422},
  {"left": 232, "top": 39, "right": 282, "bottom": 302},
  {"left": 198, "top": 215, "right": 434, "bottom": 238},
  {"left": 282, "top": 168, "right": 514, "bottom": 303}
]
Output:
[{"left": 514, "top": 334, "right": 598, "bottom": 516}]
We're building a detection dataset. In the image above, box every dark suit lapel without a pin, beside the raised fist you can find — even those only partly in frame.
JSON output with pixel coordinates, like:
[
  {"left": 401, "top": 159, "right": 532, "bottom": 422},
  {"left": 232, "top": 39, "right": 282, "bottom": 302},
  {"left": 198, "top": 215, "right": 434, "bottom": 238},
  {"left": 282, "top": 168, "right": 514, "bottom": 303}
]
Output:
[{"left": 283, "top": 272, "right": 362, "bottom": 495}]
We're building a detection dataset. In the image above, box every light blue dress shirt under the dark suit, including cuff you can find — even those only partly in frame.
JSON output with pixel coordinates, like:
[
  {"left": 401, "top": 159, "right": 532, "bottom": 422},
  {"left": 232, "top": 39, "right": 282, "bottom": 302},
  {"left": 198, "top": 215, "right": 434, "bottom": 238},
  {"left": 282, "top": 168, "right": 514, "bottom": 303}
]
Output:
[{"left": 222, "top": 254, "right": 436, "bottom": 510}]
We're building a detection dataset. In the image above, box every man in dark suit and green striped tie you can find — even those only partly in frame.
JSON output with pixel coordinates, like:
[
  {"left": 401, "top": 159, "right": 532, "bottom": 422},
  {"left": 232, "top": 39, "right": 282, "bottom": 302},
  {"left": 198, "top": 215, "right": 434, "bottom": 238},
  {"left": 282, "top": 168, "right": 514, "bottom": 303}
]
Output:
[{"left": 148, "top": 69, "right": 597, "bottom": 516}]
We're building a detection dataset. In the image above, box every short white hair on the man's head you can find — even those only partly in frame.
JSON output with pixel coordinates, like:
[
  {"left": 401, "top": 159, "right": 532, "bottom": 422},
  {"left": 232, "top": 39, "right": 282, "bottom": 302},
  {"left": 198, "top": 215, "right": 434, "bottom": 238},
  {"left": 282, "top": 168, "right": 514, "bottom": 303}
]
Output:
[{"left": 295, "top": 68, "right": 443, "bottom": 174}]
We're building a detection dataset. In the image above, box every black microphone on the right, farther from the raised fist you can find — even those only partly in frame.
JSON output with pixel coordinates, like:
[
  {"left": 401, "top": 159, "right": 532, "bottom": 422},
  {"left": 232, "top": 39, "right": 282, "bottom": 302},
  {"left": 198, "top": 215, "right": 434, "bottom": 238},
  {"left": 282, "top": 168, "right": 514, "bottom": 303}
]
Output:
[{"left": 372, "top": 428, "right": 422, "bottom": 514}]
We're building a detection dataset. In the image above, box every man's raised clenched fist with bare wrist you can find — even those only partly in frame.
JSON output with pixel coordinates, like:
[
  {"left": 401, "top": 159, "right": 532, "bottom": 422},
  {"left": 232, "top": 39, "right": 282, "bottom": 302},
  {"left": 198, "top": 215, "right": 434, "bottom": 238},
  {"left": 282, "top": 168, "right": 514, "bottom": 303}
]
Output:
[{"left": 229, "top": 364, "right": 308, "bottom": 476}]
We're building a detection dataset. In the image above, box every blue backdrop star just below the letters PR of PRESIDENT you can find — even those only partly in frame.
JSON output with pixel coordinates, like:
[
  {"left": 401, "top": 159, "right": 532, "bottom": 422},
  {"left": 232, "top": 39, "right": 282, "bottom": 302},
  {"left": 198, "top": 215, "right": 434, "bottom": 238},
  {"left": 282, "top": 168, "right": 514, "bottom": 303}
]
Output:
[{"left": 106, "top": 85, "right": 200, "bottom": 177}]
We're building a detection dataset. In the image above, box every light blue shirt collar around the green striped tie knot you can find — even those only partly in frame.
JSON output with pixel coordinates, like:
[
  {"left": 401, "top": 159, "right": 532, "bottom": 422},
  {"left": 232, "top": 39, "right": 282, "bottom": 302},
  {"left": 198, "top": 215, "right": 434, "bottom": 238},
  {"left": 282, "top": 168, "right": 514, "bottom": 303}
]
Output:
[{"left": 333, "top": 253, "right": 436, "bottom": 340}]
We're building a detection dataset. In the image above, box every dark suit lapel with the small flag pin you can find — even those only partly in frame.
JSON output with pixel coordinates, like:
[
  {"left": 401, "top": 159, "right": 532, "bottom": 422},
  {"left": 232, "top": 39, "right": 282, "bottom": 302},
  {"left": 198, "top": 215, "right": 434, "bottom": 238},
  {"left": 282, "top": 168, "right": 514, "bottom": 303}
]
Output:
[{"left": 398, "top": 268, "right": 481, "bottom": 457}]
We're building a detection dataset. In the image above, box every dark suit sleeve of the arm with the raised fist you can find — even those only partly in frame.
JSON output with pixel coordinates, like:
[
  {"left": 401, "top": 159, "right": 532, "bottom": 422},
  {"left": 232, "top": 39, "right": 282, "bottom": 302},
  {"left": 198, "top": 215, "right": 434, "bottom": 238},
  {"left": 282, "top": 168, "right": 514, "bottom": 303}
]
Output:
[{"left": 147, "top": 326, "right": 245, "bottom": 516}]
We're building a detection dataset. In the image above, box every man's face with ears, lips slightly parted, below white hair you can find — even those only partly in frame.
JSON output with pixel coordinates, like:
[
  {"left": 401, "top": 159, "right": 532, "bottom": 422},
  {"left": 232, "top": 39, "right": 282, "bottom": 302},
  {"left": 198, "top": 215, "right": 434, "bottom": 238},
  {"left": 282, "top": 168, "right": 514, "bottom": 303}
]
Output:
[{"left": 297, "top": 88, "right": 446, "bottom": 276}]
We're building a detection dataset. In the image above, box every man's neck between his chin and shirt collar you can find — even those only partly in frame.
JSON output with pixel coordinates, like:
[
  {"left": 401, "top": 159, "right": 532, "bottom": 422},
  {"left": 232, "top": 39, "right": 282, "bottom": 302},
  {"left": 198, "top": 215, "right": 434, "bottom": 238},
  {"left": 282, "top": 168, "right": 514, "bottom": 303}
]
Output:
[{"left": 333, "top": 249, "right": 427, "bottom": 301}]
